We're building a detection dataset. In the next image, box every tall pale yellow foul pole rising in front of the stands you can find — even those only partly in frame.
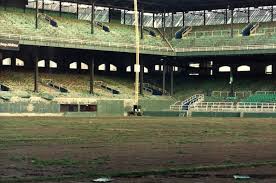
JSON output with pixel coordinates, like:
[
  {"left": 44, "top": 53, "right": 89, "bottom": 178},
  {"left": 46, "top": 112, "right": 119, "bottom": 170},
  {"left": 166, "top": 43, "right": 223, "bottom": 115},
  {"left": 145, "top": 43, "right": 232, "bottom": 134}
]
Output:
[{"left": 134, "top": 0, "right": 140, "bottom": 105}]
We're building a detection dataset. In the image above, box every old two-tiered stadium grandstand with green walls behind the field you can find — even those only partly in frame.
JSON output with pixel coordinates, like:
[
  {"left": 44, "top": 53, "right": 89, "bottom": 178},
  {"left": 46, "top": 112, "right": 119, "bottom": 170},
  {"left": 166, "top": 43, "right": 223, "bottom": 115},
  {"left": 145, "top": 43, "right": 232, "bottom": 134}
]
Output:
[{"left": 0, "top": 0, "right": 276, "bottom": 117}]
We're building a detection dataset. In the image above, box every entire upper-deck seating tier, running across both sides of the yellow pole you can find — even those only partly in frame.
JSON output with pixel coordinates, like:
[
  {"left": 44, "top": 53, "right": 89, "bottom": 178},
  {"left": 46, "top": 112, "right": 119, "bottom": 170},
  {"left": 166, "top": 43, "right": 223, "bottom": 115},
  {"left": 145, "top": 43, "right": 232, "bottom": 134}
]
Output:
[{"left": 0, "top": 7, "right": 276, "bottom": 50}]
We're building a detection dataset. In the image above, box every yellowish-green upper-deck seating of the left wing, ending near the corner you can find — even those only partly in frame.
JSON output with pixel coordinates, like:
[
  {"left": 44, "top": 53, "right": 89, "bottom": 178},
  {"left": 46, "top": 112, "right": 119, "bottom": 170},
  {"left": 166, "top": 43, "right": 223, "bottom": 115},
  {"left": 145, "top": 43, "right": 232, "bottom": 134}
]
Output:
[{"left": 0, "top": 7, "right": 166, "bottom": 47}]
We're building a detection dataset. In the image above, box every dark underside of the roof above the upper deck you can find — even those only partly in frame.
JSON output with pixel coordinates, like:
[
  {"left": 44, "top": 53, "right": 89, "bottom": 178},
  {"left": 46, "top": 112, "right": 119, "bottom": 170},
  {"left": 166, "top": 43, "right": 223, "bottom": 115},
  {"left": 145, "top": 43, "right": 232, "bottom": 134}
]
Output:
[{"left": 62, "top": 0, "right": 276, "bottom": 12}]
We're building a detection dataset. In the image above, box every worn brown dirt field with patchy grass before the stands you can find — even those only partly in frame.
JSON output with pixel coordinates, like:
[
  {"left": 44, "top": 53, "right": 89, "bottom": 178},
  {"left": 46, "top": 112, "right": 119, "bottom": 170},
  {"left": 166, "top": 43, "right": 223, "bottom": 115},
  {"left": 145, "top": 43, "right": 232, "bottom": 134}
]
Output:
[{"left": 0, "top": 118, "right": 276, "bottom": 183}]
